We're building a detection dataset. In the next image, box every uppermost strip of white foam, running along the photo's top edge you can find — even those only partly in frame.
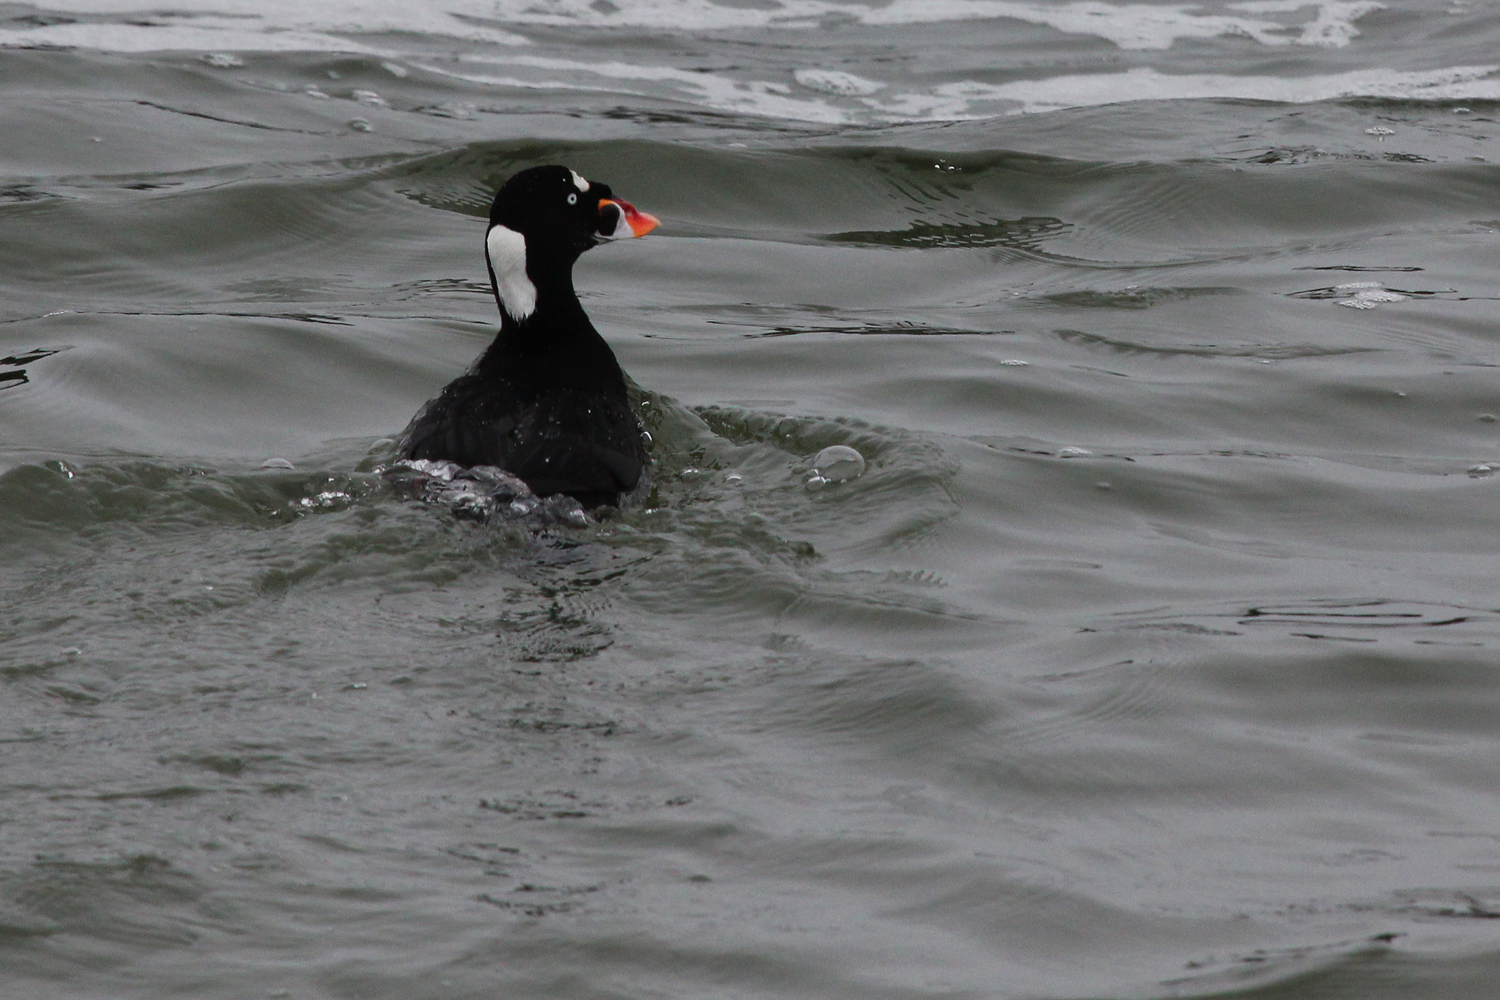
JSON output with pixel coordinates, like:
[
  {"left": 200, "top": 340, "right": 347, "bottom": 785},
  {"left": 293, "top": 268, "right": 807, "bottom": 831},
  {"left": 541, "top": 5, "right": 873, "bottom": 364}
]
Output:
[{"left": 0, "top": 0, "right": 1385, "bottom": 52}]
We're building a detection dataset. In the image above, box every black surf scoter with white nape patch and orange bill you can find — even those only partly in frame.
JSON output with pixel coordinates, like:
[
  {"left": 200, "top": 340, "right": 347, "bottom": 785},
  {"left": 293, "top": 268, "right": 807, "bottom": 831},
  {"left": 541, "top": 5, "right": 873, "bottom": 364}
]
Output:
[{"left": 401, "top": 166, "right": 659, "bottom": 507}]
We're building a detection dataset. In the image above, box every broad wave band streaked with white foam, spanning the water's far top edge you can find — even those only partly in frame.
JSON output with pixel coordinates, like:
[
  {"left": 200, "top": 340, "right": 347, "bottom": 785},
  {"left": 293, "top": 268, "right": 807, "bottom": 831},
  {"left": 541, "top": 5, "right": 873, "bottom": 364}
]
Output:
[{"left": 0, "top": 0, "right": 1500, "bottom": 126}]
